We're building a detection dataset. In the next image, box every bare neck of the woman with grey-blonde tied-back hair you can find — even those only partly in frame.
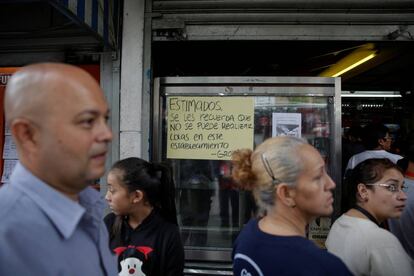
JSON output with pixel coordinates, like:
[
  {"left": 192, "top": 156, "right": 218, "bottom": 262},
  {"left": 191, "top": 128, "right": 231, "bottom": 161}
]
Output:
[{"left": 259, "top": 207, "right": 308, "bottom": 237}]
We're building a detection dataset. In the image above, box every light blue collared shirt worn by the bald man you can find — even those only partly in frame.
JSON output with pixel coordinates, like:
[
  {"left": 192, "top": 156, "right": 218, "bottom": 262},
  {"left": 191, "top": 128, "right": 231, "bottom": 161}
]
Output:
[{"left": 0, "top": 163, "right": 118, "bottom": 276}]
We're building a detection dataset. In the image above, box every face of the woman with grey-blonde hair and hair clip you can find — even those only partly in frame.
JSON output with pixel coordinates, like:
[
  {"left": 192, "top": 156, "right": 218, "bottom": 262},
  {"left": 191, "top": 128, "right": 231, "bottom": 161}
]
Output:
[{"left": 294, "top": 145, "right": 335, "bottom": 221}]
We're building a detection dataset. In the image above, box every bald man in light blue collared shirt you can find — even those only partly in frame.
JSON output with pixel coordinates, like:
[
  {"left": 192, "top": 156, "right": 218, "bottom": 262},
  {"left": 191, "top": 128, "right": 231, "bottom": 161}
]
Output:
[{"left": 0, "top": 63, "right": 117, "bottom": 276}]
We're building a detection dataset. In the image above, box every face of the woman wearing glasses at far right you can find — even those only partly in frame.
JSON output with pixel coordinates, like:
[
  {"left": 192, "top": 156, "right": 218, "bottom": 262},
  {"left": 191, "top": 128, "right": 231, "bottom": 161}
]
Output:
[{"left": 365, "top": 169, "right": 407, "bottom": 221}]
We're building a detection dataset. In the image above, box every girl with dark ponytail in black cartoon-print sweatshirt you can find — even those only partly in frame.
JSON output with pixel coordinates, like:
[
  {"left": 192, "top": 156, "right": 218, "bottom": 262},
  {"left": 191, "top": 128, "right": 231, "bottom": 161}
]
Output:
[{"left": 105, "top": 157, "right": 184, "bottom": 276}]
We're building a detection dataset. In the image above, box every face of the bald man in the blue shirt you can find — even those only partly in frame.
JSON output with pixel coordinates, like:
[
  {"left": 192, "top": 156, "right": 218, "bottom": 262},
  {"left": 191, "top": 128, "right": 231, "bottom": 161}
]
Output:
[{"left": 38, "top": 73, "right": 112, "bottom": 192}]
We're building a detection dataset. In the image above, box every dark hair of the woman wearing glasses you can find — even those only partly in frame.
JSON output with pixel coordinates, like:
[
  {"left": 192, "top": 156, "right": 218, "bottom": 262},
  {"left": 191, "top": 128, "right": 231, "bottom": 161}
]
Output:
[{"left": 345, "top": 158, "right": 403, "bottom": 208}]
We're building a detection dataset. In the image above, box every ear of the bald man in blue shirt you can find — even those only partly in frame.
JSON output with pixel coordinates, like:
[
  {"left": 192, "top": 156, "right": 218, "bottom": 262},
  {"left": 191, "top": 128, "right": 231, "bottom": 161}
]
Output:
[{"left": 10, "top": 118, "right": 37, "bottom": 151}]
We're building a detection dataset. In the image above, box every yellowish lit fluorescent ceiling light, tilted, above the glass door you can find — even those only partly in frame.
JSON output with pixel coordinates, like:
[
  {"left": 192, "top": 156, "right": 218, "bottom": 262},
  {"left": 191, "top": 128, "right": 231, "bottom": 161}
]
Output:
[{"left": 320, "top": 43, "right": 377, "bottom": 77}]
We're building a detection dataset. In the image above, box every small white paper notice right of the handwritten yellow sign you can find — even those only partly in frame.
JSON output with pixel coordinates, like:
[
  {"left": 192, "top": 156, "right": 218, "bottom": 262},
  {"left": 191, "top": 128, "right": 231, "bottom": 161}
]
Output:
[{"left": 272, "top": 113, "right": 302, "bottom": 138}]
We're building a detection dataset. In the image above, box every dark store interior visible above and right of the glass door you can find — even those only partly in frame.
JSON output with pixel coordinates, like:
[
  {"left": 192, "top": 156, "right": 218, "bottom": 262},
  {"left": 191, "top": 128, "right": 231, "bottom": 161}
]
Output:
[{"left": 152, "top": 40, "right": 414, "bottom": 140}]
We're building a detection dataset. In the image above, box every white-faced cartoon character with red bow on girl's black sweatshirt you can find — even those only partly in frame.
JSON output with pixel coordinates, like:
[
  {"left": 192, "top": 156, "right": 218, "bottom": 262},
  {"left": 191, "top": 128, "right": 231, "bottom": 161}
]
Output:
[{"left": 114, "top": 245, "right": 154, "bottom": 276}]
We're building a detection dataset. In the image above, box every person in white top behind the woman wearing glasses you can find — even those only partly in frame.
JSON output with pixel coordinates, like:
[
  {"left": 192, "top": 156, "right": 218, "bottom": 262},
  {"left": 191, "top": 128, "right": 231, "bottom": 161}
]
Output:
[{"left": 345, "top": 124, "right": 402, "bottom": 172}]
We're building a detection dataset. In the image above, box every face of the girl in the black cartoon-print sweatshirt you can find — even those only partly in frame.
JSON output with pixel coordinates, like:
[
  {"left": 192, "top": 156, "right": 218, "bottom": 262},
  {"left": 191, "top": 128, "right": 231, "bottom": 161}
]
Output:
[{"left": 105, "top": 170, "right": 135, "bottom": 216}]
